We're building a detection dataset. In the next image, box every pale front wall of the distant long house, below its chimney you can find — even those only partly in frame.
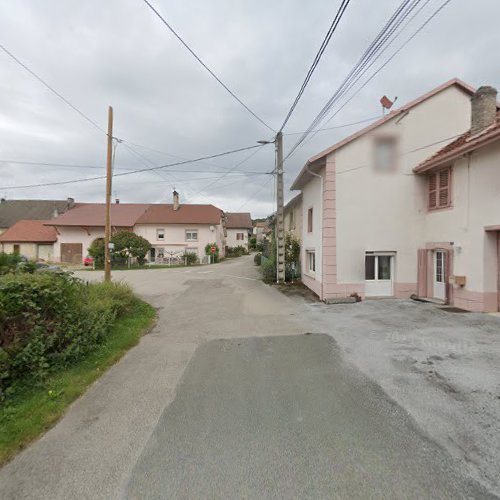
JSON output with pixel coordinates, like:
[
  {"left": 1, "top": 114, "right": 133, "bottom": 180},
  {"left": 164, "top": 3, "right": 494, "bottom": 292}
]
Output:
[{"left": 134, "top": 224, "right": 225, "bottom": 258}]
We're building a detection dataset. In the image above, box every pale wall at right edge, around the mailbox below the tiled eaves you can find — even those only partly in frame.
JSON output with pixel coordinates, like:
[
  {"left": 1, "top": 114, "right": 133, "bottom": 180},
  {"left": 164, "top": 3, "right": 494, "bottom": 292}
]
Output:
[{"left": 420, "top": 143, "right": 500, "bottom": 311}]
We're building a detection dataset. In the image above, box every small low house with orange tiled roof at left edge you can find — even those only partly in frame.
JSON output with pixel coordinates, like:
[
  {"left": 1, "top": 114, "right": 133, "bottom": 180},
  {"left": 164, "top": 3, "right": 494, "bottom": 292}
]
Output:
[{"left": 0, "top": 220, "right": 57, "bottom": 261}]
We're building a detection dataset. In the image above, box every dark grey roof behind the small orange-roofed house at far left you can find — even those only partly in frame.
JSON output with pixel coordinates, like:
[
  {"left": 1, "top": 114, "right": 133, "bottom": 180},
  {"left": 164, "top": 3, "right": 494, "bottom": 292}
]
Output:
[{"left": 0, "top": 198, "right": 76, "bottom": 234}]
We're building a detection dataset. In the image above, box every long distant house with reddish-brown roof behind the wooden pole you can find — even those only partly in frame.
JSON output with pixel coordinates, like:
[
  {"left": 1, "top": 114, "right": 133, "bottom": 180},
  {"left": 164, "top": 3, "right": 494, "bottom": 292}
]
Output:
[{"left": 47, "top": 191, "right": 225, "bottom": 263}]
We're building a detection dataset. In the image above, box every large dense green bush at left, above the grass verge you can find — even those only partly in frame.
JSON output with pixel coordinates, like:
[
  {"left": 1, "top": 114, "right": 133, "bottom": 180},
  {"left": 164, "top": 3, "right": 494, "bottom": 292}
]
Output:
[{"left": 0, "top": 272, "right": 134, "bottom": 399}]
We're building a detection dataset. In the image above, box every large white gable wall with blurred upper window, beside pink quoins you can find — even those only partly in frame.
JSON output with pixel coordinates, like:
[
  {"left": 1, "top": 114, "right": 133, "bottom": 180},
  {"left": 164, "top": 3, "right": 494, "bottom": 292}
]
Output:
[{"left": 327, "top": 87, "right": 470, "bottom": 296}]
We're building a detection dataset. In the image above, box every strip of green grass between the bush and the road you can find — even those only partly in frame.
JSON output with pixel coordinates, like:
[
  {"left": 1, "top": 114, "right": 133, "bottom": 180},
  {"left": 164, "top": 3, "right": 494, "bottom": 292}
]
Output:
[{"left": 0, "top": 299, "right": 156, "bottom": 465}]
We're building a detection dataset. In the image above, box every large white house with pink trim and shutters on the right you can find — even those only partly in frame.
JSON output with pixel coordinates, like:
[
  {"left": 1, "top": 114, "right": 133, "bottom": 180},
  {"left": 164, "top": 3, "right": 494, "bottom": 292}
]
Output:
[{"left": 292, "top": 79, "right": 500, "bottom": 311}]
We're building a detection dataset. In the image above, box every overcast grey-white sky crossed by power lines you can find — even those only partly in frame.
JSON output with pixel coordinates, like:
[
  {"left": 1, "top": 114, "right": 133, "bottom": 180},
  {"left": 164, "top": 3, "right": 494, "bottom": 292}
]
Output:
[{"left": 0, "top": 0, "right": 500, "bottom": 216}]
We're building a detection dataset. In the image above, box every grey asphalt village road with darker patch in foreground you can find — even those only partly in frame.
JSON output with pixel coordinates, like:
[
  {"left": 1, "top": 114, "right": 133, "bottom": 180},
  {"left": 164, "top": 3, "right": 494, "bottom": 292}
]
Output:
[{"left": 0, "top": 258, "right": 491, "bottom": 500}]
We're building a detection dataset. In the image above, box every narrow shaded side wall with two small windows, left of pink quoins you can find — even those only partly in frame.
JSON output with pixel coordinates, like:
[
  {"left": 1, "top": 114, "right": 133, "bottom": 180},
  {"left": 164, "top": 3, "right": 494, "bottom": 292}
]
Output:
[{"left": 301, "top": 168, "right": 325, "bottom": 299}]
